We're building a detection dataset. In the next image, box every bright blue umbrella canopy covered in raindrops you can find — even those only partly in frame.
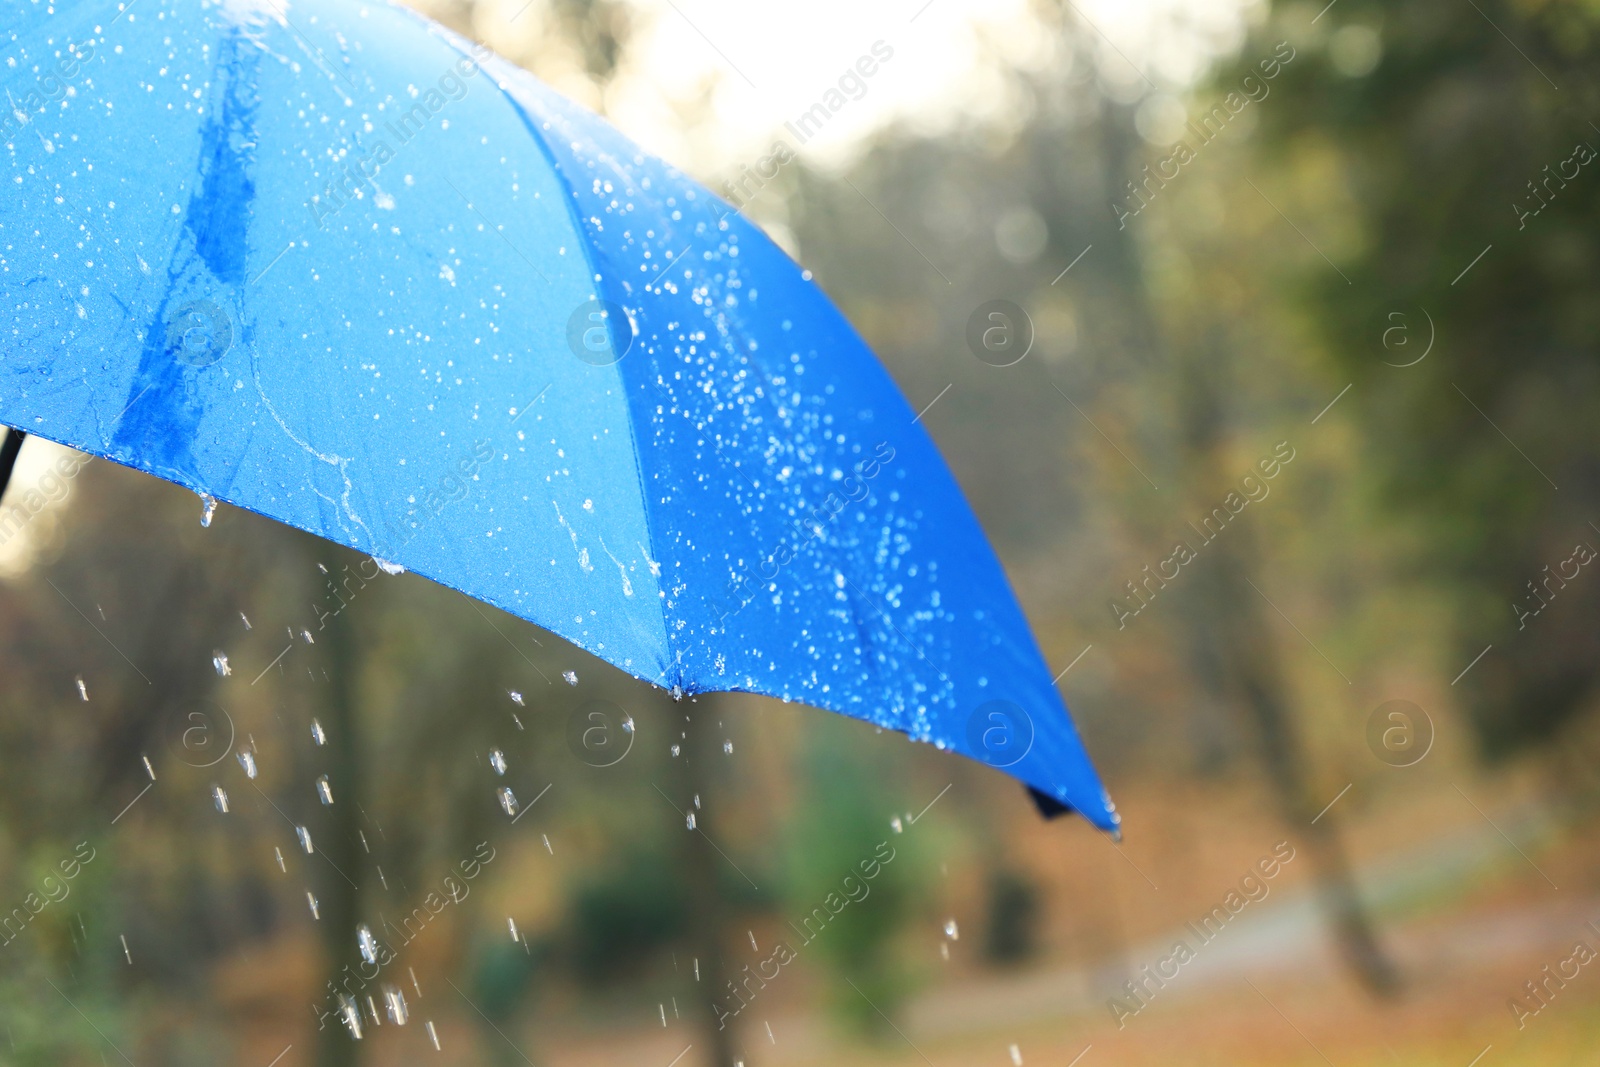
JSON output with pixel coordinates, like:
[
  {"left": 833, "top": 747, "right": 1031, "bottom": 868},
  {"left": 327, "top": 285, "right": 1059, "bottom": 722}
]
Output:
[{"left": 0, "top": 0, "right": 1117, "bottom": 829}]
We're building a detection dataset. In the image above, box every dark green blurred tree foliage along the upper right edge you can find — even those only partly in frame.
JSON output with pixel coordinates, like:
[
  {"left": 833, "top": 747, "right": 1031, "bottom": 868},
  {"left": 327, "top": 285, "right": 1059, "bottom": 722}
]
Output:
[{"left": 1219, "top": 0, "right": 1600, "bottom": 760}]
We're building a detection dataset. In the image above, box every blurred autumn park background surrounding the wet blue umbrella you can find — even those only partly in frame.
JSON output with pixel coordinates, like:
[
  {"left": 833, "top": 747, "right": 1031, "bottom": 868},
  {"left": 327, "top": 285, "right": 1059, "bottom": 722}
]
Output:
[{"left": 0, "top": 0, "right": 1600, "bottom": 1067}]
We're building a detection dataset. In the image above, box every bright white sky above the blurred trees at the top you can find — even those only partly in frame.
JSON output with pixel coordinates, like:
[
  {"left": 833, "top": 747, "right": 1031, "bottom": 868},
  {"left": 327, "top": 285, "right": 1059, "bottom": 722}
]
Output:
[{"left": 470, "top": 0, "right": 1259, "bottom": 174}]
